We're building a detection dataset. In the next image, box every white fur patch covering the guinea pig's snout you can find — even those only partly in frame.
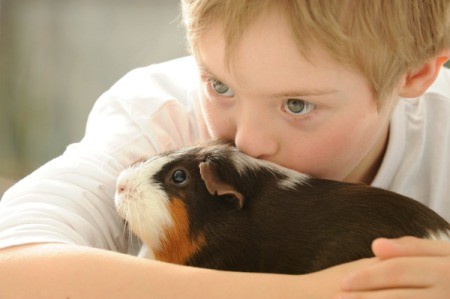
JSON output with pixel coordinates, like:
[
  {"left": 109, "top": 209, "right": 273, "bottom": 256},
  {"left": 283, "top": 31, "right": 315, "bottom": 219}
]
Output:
[{"left": 114, "top": 157, "right": 174, "bottom": 250}]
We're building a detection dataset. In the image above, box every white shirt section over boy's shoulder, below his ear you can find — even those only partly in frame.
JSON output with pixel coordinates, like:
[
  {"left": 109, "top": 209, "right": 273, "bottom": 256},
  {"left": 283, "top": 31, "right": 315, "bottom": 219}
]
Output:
[{"left": 373, "top": 69, "right": 450, "bottom": 221}]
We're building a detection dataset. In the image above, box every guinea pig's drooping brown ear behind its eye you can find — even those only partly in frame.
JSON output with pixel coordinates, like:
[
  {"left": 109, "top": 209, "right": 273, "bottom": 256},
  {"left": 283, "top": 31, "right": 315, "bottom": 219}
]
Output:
[{"left": 199, "top": 162, "right": 244, "bottom": 209}]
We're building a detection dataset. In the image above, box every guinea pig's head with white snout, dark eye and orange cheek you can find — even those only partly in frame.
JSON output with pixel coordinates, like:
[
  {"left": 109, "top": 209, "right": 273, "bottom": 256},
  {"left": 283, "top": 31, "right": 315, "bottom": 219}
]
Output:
[{"left": 115, "top": 142, "right": 270, "bottom": 264}]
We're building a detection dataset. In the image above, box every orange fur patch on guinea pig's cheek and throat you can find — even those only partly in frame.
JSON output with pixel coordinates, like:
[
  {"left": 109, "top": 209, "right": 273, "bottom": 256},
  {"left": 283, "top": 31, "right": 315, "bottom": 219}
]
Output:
[{"left": 154, "top": 198, "right": 205, "bottom": 265}]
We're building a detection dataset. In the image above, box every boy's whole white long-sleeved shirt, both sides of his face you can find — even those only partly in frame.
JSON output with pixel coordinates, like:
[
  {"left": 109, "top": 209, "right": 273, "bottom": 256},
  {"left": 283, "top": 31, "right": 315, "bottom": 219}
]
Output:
[{"left": 0, "top": 57, "right": 450, "bottom": 252}]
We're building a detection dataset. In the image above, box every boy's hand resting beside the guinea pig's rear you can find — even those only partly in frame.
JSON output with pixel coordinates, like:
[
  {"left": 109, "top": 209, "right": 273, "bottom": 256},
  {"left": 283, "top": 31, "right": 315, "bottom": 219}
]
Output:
[{"left": 336, "top": 237, "right": 450, "bottom": 299}]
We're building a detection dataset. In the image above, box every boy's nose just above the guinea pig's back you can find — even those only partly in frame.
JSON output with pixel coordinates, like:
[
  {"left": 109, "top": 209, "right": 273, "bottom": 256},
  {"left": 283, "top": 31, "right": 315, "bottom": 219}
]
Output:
[{"left": 234, "top": 113, "right": 278, "bottom": 159}]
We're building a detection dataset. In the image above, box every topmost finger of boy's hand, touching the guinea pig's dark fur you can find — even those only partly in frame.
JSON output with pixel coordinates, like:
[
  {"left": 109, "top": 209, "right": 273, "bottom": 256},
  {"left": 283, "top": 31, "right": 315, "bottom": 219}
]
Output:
[{"left": 372, "top": 237, "right": 450, "bottom": 259}]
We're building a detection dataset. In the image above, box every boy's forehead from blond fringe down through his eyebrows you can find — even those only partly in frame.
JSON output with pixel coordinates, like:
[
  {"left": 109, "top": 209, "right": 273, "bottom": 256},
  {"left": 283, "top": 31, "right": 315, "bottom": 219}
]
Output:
[{"left": 195, "top": 14, "right": 384, "bottom": 106}]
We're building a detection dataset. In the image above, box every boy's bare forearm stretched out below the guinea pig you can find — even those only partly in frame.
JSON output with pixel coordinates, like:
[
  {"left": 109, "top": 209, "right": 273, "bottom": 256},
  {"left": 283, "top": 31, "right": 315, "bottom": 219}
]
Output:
[{"left": 0, "top": 244, "right": 371, "bottom": 299}]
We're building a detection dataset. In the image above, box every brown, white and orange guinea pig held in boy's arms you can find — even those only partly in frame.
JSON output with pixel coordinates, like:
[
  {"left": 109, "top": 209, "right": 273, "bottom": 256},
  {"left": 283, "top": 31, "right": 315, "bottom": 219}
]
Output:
[{"left": 115, "top": 142, "right": 450, "bottom": 274}]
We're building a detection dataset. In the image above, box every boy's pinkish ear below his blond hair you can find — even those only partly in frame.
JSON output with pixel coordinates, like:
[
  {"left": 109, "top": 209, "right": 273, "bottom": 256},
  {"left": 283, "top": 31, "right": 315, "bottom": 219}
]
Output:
[{"left": 399, "top": 48, "right": 450, "bottom": 98}]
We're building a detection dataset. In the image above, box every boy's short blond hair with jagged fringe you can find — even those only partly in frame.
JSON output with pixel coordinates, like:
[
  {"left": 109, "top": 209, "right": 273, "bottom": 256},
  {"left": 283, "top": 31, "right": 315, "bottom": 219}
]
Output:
[{"left": 182, "top": 0, "right": 450, "bottom": 103}]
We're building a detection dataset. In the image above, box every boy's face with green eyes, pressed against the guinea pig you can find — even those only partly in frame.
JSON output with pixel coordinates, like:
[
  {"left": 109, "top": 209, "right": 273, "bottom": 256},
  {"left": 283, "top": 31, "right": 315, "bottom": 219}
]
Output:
[{"left": 197, "top": 13, "right": 390, "bottom": 183}]
